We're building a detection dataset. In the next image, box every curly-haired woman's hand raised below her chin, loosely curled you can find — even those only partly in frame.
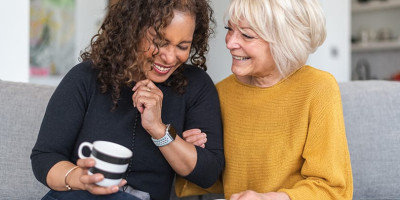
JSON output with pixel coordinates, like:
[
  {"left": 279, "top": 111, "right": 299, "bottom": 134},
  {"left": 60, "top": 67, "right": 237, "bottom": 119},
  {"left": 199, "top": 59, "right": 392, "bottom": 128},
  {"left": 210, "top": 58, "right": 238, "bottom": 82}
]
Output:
[{"left": 132, "top": 79, "right": 165, "bottom": 138}]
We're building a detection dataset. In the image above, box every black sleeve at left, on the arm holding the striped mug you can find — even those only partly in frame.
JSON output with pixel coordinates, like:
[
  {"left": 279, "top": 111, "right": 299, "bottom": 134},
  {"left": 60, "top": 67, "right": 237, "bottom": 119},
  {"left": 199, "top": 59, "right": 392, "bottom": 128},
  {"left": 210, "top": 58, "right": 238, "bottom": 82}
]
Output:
[{"left": 31, "top": 62, "right": 95, "bottom": 186}]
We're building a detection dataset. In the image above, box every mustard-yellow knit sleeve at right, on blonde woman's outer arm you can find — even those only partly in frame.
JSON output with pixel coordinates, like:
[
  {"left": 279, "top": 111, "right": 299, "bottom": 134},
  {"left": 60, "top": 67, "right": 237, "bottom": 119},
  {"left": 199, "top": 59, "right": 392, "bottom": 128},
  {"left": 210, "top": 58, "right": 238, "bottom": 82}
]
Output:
[{"left": 279, "top": 76, "right": 353, "bottom": 200}]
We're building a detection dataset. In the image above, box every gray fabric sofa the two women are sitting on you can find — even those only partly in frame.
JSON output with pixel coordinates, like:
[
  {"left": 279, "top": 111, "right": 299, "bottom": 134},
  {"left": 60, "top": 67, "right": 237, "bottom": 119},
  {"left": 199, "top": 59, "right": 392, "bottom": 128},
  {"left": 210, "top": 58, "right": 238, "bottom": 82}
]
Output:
[{"left": 0, "top": 81, "right": 400, "bottom": 200}]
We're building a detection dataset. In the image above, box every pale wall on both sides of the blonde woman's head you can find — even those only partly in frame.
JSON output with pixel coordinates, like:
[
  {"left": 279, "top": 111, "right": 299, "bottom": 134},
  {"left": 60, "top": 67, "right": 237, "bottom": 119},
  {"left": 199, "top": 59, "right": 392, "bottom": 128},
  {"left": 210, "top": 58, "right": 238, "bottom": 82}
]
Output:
[{"left": 207, "top": 0, "right": 351, "bottom": 83}]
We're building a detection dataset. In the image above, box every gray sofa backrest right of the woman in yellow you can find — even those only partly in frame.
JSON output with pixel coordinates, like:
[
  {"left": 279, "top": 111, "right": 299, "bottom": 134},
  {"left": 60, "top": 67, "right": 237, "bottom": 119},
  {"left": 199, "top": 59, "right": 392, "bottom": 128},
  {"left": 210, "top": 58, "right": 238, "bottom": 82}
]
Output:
[{"left": 340, "top": 81, "right": 400, "bottom": 199}]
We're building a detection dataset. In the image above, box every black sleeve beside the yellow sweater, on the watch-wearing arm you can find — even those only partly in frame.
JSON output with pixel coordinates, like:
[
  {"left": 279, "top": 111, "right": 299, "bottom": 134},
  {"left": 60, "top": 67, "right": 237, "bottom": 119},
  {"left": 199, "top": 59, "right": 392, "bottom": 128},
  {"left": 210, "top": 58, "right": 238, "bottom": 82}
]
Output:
[{"left": 179, "top": 67, "right": 225, "bottom": 188}]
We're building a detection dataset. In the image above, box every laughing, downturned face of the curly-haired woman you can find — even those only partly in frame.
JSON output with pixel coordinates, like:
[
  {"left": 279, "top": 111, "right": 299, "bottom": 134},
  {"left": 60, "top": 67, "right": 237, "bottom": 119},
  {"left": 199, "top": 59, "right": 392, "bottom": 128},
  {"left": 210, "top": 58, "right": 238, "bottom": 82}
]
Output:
[{"left": 140, "top": 10, "right": 195, "bottom": 83}]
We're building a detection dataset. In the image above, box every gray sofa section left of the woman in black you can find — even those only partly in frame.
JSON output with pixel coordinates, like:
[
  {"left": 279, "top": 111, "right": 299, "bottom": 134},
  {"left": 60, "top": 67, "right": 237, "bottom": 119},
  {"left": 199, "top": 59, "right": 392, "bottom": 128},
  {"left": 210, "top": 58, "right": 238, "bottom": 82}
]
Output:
[{"left": 0, "top": 80, "right": 54, "bottom": 200}]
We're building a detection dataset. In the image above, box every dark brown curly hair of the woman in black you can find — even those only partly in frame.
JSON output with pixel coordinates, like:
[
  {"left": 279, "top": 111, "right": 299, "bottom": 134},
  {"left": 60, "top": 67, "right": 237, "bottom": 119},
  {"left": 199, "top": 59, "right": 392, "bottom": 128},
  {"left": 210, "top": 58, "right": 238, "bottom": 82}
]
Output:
[{"left": 81, "top": 0, "right": 215, "bottom": 106}]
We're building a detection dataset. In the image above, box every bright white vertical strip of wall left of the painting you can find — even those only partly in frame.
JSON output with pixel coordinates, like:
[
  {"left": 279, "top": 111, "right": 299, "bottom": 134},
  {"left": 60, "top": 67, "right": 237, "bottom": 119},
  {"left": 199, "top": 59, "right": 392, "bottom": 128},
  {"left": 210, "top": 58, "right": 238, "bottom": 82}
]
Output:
[{"left": 0, "top": 0, "right": 29, "bottom": 82}]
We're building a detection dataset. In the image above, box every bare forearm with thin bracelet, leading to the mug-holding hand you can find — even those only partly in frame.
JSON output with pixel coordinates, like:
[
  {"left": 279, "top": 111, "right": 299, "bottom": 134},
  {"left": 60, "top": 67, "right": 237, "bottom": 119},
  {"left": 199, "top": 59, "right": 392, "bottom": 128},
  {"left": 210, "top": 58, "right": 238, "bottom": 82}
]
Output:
[{"left": 46, "top": 161, "right": 83, "bottom": 191}]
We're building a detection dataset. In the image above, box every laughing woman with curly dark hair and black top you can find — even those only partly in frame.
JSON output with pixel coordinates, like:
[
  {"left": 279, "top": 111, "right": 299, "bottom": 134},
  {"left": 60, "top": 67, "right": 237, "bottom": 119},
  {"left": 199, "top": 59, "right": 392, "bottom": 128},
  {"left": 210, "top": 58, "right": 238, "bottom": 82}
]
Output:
[{"left": 31, "top": 0, "right": 224, "bottom": 200}]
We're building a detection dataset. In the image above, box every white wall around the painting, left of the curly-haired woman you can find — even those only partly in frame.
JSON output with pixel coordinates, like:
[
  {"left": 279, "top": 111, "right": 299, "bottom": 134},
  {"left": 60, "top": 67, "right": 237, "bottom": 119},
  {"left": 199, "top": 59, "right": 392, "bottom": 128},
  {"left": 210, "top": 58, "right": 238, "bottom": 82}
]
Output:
[{"left": 0, "top": 0, "right": 108, "bottom": 85}]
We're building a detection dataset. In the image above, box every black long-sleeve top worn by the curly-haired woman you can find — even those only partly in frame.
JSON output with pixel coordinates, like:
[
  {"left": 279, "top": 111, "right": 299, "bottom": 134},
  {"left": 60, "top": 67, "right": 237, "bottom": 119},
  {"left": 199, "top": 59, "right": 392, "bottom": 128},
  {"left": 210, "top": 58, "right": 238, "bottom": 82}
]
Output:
[{"left": 31, "top": 62, "right": 225, "bottom": 199}]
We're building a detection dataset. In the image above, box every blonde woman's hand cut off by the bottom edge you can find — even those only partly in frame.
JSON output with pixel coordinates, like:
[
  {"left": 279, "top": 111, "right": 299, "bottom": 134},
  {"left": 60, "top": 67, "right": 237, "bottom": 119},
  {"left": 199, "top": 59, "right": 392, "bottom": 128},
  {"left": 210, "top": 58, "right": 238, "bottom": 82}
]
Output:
[{"left": 230, "top": 190, "right": 290, "bottom": 200}]
